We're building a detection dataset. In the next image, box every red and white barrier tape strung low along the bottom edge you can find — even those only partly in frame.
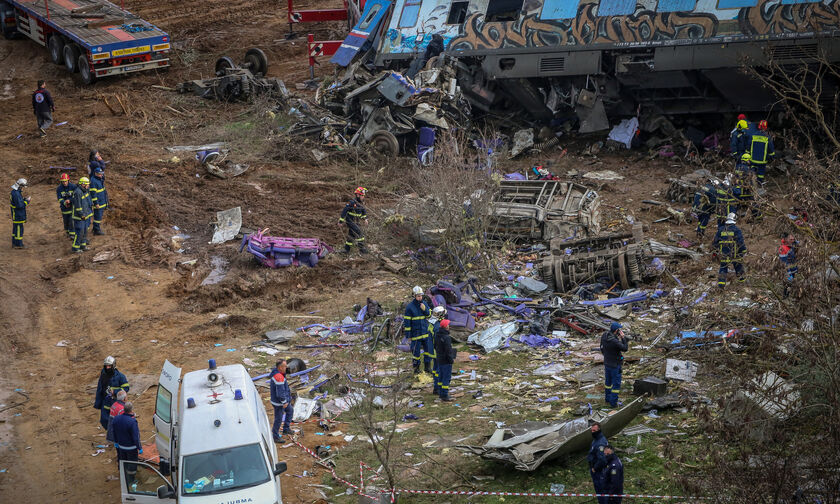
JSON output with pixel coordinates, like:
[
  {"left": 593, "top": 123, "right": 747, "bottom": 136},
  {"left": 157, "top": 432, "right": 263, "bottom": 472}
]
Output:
[{"left": 292, "top": 439, "right": 709, "bottom": 502}]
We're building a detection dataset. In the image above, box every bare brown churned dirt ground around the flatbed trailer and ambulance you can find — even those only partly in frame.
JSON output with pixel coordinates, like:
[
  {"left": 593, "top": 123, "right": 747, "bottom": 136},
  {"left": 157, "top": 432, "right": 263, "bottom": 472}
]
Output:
[{"left": 0, "top": 0, "right": 796, "bottom": 503}]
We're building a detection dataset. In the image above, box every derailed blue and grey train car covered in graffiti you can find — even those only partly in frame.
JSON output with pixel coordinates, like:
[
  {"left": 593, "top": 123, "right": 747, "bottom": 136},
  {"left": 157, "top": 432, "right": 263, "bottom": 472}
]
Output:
[{"left": 344, "top": 0, "right": 840, "bottom": 120}]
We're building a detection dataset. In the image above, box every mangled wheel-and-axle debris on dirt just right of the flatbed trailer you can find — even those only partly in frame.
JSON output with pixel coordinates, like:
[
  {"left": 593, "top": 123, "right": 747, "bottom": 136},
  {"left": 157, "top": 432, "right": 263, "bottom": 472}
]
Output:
[{"left": 176, "top": 48, "right": 289, "bottom": 101}]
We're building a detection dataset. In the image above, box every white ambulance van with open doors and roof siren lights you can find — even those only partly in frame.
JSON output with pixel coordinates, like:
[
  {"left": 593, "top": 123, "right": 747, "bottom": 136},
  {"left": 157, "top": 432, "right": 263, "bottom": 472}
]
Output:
[{"left": 120, "top": 360, "right": 286, "bottom": 504}]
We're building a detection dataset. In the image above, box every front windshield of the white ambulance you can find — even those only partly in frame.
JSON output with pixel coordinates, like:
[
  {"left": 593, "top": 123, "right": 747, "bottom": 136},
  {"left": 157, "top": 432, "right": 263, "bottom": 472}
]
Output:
[{"left": 181, "top": 444, "right": 271, "bottom": 496}]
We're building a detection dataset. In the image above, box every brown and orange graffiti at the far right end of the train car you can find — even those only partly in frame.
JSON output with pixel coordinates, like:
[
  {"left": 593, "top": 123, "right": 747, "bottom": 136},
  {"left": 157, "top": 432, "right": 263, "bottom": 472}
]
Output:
[{"left": 738, "top": 0, "right": 840, "bottom": 35}]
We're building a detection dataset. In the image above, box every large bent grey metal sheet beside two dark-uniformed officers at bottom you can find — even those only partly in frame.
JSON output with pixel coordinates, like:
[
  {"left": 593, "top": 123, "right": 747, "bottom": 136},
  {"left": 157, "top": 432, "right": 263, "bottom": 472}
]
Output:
[{"left": 458, "top": 396, "right": 646, "bottom": 471}]
